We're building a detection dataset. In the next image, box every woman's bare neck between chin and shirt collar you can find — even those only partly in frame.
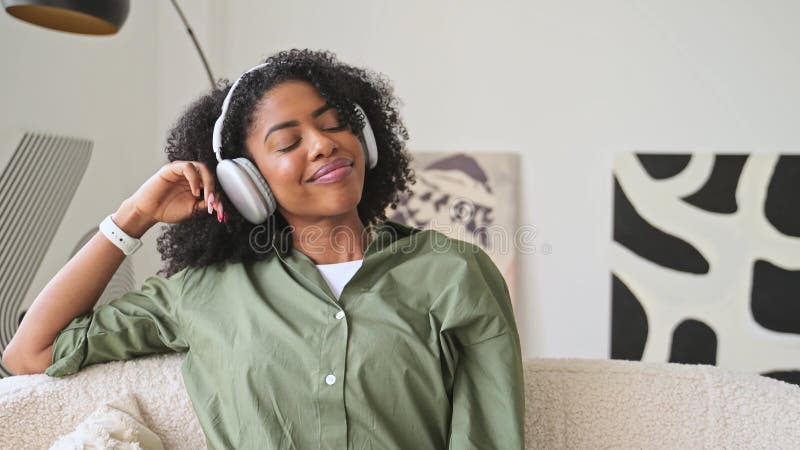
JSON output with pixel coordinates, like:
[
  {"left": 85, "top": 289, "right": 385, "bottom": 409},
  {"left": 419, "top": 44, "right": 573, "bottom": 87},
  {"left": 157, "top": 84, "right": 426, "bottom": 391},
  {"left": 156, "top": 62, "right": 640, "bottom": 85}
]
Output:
[{"left": 284, "top": 210, "right": 370, "bottom": 264}]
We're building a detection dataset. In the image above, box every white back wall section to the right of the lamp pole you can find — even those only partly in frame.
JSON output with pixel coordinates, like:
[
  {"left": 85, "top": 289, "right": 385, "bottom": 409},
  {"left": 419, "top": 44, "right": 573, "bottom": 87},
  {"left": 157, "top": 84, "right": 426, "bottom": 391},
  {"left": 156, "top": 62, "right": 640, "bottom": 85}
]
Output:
[{"left": 219, "top": 0, "right": 800, "bottom": 357}]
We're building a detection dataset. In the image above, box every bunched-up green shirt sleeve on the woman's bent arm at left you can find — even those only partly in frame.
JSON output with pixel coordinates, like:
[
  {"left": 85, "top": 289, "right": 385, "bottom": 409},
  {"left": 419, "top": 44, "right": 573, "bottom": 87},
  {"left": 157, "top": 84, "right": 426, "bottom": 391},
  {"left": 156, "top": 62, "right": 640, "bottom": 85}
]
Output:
[{"left": 44, "top": 269, "right": 189, "bottom": 377}]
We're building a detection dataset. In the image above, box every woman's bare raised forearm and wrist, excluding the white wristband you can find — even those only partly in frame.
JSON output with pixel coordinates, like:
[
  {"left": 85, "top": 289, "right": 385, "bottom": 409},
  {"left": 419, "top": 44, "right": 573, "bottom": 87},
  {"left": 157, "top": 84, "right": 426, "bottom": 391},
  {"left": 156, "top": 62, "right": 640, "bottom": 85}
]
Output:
[{"left": 3, "top": 201, "right": 153, "bottom": 374}]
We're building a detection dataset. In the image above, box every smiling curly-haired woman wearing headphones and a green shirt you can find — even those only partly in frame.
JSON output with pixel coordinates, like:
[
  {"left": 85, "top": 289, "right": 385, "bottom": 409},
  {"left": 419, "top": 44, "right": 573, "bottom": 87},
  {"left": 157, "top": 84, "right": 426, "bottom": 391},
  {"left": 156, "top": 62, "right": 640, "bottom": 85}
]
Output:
[{"left": 4, "top": 50, "right": 524, "bottom": 449}]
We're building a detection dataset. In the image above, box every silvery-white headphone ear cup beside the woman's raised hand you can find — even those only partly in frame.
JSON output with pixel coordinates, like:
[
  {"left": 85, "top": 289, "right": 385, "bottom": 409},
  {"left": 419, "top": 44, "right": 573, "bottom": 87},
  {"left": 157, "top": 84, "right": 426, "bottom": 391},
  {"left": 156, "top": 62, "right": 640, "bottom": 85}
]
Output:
[{"left": 217, "top": 158, "right": 277, "bottom": 224}]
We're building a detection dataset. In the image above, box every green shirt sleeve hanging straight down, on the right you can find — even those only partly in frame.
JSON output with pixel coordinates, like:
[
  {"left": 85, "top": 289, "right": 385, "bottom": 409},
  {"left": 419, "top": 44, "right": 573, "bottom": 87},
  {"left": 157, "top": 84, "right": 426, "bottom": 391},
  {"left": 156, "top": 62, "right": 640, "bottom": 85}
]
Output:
[{"left": 440, "top": 246, "right": 525, "bottom": 450}]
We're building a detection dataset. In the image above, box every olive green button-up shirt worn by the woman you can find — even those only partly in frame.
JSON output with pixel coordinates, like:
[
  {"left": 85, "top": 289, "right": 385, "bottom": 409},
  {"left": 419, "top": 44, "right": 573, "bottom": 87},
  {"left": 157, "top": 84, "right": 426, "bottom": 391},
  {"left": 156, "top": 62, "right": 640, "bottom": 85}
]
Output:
[{"left": 45, "top": 221, "right": 525, "bottom": 450}]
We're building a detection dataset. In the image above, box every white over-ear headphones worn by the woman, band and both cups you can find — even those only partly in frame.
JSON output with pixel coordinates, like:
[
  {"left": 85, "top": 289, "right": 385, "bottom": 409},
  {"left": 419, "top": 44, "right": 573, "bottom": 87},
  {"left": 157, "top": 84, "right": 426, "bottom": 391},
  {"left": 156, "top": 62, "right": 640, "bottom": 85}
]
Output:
[{"left": 212, "top": 63, "right": 378, "bottom": 224}]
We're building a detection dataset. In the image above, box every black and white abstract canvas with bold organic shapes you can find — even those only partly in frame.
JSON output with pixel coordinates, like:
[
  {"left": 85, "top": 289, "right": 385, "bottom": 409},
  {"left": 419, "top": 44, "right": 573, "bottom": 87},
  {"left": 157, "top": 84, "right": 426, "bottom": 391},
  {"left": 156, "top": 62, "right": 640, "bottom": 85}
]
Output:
[{"left": 611, "top": 153, "right": 800, "bottom": 384}]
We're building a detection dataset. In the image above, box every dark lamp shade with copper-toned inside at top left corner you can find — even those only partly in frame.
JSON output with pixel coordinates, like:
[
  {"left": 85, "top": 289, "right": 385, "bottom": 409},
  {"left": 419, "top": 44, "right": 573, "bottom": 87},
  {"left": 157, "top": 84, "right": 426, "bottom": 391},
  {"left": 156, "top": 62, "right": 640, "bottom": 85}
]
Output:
[{"left": 2, "top": 0, "right": 130, "bottom": 35}]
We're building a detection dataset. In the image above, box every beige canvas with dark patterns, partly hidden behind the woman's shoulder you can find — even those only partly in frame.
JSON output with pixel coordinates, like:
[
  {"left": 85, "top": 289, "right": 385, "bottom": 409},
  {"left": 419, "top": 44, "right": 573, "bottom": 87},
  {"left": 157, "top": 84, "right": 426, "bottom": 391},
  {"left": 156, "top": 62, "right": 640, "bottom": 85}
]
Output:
[{"left": 387, "top": 152, "right": 519, "bottom": 301}]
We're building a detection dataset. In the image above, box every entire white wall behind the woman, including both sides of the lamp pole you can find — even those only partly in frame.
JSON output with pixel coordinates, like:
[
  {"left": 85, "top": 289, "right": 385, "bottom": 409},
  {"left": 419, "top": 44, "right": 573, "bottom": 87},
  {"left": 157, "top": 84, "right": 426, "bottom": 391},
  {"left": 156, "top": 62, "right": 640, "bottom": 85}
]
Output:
[{"left": 0, "top": 0, "right": 800, "bottom": 358}]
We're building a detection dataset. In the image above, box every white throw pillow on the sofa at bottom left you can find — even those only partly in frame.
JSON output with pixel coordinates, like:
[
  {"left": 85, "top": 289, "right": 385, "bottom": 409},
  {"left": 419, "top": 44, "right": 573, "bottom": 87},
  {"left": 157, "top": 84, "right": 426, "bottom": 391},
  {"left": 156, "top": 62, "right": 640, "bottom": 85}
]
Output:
[{"left": 50, "top": 393, "right": 164, "bottom": 450}]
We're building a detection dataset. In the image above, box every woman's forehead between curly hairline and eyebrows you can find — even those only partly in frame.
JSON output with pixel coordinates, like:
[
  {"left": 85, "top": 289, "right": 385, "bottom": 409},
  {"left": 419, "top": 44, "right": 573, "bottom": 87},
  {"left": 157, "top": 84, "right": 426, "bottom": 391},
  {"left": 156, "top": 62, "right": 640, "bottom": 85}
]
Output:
[{"left": 254, "top": 80, "right": 325, "bottom": 126}]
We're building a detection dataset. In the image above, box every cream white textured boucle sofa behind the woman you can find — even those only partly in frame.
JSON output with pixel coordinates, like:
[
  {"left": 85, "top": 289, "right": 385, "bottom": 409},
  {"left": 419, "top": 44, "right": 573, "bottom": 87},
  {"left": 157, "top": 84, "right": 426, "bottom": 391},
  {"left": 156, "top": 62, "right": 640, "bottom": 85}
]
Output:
[{"left": 0, "top": 354, "right": 800, "bottom": 450}]
